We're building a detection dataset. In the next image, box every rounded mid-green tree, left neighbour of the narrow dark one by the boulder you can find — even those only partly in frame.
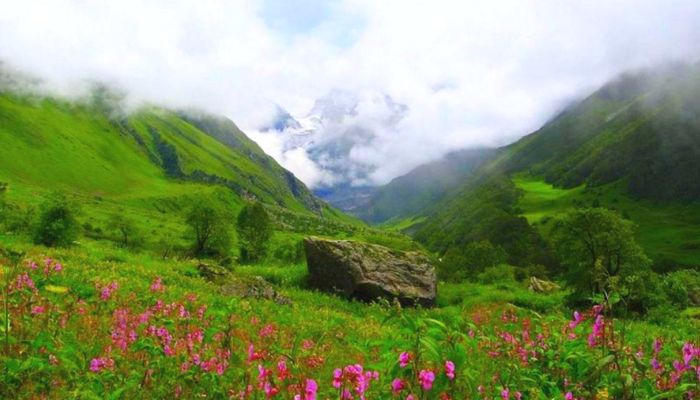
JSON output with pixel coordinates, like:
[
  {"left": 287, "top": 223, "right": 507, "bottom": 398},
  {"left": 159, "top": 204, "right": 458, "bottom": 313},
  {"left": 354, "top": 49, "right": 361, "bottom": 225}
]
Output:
[{"left": 186, "top": 201, "right": 231, "bottom": 256}]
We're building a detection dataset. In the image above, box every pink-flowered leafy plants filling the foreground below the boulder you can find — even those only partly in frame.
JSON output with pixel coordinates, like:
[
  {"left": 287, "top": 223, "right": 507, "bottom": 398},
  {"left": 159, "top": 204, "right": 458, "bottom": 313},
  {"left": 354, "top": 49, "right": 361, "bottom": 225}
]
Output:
[{"left": 0, "top": 258, "right": 700, "bottom": 400}]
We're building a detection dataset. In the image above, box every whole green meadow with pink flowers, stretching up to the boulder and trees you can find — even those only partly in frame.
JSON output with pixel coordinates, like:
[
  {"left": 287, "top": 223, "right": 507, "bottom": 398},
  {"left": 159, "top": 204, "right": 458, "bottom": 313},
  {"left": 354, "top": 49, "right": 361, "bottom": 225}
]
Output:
[{"left": 0, "top": 230, "right": 700, "bottom": 399}]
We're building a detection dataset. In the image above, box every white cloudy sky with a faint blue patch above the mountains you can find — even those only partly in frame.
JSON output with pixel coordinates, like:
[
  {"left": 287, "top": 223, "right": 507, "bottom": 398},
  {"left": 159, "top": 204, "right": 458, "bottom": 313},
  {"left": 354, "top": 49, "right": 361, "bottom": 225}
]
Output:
[{"left": 0, "top": 0, "right": 700, "bottom": 185}]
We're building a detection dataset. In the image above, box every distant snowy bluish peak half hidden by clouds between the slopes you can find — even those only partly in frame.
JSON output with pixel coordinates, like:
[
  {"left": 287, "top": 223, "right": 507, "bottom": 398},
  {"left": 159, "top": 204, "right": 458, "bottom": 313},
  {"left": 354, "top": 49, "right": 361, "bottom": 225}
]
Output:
[{"left": 261, "top": 89, "right": 409, "bottom": 202}]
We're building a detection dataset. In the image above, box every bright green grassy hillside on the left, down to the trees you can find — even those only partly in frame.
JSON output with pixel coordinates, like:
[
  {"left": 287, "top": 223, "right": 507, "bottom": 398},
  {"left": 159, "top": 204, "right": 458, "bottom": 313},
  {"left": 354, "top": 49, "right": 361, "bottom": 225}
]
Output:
[{"left": 0, "top": 85, "right": 424, "bottom": 260}]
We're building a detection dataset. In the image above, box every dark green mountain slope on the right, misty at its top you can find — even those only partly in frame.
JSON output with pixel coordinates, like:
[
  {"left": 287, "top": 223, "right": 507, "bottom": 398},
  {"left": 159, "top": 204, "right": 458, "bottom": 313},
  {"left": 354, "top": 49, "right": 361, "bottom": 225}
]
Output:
[{"left": 402, "top": 65, "right": 700, "bottom": 268}]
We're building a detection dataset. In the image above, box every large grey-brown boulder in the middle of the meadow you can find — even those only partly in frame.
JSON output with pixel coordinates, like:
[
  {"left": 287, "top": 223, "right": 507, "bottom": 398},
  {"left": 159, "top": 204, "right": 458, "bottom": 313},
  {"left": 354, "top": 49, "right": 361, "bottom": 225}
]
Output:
[{"left": 304, "top": 237, "right": 437, "bottom": 306}]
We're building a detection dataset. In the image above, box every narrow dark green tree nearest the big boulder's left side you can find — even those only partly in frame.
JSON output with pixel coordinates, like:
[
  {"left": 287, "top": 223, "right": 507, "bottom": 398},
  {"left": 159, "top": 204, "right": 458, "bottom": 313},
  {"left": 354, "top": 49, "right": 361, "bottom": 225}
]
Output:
[{"left": 236, "top": 202, "right": 272, "bottom": 263}]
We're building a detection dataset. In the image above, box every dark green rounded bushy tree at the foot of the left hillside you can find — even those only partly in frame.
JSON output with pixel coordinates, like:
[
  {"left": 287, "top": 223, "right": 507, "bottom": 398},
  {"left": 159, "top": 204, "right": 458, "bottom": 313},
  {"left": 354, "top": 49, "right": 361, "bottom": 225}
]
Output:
[{"left": 34, "top": 196, "right": 78, "bottom": 247}]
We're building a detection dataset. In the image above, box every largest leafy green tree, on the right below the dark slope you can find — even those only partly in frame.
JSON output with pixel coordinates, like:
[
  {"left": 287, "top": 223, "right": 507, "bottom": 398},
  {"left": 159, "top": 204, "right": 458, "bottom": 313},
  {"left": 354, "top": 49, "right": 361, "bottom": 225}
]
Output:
[{"left": 554, "top": 208, "right": 651, "bottom": 302}]
